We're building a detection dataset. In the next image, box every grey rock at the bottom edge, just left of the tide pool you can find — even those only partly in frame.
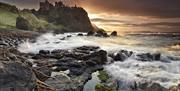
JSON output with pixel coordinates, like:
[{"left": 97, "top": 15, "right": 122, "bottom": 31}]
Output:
[{"left": 45, "top": 75, "right": 88, "bottom": 91}]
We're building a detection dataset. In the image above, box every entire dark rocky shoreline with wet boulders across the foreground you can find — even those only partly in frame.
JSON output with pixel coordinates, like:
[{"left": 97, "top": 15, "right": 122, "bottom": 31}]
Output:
[{"left": 0, "top": 32, "right": 180, "bottom": 91}]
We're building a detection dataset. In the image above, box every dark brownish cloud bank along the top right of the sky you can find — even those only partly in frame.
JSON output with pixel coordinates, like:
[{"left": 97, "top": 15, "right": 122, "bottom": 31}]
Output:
[{"left": 81, "top": 0, "right": 180, "bottom": 18}]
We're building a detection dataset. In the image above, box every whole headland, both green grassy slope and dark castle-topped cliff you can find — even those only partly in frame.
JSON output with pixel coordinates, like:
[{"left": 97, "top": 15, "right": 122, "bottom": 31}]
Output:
[{"left": 0, "top": 1, "right": 94, "bottom": 33}]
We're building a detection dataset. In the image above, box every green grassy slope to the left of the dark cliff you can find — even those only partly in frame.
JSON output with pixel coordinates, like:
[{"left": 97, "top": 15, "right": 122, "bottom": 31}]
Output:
[{"left": 0, "top": 8, "right": 66, "bottom": 31}]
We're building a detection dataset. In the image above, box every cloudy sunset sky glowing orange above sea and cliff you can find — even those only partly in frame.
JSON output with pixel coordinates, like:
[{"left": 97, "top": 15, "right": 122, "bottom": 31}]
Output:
[{"left": 0, "top": 0, "right": 180, "bottom": 32}]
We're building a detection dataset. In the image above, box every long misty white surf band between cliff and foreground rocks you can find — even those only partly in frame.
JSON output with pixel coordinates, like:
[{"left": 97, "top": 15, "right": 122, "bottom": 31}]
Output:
[{"left": 18, "top": 33, "right": 162, "bottom": 53}]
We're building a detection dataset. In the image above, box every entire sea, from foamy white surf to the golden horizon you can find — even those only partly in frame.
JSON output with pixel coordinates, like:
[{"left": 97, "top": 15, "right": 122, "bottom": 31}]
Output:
[{"left": 18, "top": 32, "right": 180, "bottom": 88}]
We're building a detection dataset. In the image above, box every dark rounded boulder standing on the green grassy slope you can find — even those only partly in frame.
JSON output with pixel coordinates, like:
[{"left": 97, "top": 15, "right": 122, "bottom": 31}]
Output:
[{"left": 16, "top": 16, "right": 30, "bottom": 30}]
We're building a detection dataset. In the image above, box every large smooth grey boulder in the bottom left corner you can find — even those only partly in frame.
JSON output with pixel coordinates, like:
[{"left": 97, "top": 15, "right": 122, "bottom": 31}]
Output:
[{"left": 0, "top": 62, "right": 36, "bottom": 91}]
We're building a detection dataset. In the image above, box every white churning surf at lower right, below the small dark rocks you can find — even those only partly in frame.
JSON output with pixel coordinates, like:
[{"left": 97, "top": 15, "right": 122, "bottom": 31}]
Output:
[{"left": 105, "top": 58, "right": 180, "bottom": 88}]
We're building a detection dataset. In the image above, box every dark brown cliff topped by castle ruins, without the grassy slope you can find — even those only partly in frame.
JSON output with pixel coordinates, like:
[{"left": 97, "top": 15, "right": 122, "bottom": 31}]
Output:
[{"left": 35, "top": 1, "right": 93, "bottom": 32}]
